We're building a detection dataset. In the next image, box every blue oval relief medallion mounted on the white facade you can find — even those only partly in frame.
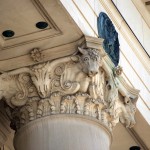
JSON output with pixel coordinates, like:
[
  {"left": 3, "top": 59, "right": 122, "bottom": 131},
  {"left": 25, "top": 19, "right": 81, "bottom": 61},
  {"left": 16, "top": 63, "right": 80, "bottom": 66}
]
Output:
[{"left": 97, "top": 12, "right": 119, "bottom": 66}]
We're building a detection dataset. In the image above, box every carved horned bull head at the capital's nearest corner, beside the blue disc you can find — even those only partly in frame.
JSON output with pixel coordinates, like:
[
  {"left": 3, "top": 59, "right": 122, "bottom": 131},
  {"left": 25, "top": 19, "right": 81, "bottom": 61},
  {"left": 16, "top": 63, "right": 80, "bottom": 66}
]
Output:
[{"left": 78, "top": 48, "right": 105, "bottom": 77}]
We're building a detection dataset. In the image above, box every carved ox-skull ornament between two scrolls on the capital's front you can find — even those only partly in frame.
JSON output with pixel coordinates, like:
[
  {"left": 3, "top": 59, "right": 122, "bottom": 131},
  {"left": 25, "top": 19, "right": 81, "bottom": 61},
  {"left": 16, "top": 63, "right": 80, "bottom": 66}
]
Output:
[{"left": 31, "top": 63, "right": 50, "bottom": 98}]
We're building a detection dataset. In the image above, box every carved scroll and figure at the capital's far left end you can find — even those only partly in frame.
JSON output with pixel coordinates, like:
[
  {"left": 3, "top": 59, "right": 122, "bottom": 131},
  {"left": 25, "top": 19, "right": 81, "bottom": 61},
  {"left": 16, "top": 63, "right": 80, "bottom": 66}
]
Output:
[{"left": 0, "top": 73, "right": 35, "bottom": 107}]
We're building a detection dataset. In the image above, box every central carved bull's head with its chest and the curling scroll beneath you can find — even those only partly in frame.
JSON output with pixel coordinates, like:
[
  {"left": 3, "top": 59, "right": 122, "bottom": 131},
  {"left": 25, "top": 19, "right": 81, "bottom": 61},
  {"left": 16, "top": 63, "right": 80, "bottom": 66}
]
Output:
[{"left": 57, "top": 48, "right": 104, "bottom": 98}]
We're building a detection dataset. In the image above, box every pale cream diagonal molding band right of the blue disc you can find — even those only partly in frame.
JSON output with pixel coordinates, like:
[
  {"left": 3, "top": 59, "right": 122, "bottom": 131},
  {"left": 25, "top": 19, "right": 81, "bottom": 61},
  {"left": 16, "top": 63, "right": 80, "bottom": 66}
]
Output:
[{"left": 99, "top": 0, "right": 150, "bottom": 74}]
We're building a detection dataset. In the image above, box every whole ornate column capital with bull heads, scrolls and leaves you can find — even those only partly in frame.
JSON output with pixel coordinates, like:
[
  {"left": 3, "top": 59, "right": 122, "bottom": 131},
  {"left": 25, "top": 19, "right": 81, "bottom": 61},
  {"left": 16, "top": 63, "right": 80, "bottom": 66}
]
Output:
[{"left": 0, "top": 48, "right": 139, "bottom": 130}]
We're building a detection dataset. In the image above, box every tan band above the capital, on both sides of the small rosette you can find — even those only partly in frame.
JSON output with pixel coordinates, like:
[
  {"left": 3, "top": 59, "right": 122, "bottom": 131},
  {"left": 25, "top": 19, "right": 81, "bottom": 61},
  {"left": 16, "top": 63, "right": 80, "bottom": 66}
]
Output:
[{"left": 0, "top": 37, "right": 85, "bottom": 72}]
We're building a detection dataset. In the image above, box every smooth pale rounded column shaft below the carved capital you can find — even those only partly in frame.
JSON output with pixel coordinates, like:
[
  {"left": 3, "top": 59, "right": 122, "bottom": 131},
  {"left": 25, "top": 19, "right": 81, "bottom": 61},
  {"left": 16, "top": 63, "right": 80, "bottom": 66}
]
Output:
[{"left": 14, "top": 115, "right": 111, "bottom": 150}]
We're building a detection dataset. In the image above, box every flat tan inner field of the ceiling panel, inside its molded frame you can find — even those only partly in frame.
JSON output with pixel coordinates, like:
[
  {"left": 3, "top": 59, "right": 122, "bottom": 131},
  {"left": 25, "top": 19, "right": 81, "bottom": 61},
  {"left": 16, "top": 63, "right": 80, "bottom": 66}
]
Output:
[{"left": 0, "top": 0, "right": 49, "bottom": 39}]
